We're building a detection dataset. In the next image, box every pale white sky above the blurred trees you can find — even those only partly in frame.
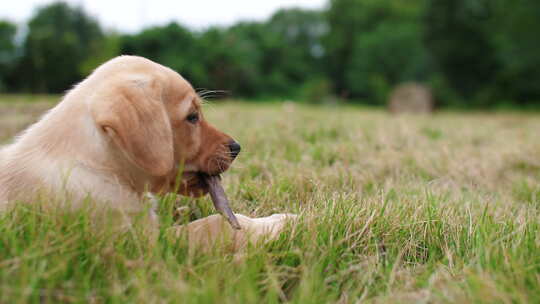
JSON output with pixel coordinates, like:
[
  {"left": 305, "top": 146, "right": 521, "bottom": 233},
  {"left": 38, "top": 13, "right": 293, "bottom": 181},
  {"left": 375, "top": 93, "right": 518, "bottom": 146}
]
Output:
[{"left": 0, "top": 0, "right": 327, "bottom": 33}]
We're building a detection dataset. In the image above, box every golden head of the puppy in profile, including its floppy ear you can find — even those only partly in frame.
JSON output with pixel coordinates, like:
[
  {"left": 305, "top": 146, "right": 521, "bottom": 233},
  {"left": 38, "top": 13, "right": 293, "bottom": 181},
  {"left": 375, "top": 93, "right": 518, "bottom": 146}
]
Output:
[{"left": 90, "top": 56, "right": 240, "bottom": 196}]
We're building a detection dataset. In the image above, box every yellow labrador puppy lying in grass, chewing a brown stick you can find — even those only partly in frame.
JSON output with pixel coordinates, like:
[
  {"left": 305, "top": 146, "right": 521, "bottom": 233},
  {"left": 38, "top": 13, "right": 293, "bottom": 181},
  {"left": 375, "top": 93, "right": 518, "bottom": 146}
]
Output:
[{"left": 0, "top": 56, "right": 296, "bottom": 247}]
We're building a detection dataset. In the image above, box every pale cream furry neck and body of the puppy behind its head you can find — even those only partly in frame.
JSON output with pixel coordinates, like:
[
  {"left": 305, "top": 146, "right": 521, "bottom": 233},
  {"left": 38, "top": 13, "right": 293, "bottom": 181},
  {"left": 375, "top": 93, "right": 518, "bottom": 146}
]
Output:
[{"left": 0, "top": 57, "right": 169, "bottom": 209}]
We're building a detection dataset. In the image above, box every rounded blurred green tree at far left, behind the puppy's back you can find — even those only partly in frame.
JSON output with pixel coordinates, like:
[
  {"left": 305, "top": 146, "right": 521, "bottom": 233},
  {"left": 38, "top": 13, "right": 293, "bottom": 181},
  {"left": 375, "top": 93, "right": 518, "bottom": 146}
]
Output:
[{"left": 15, "top": 2, "right": 104, "bottom": 92}]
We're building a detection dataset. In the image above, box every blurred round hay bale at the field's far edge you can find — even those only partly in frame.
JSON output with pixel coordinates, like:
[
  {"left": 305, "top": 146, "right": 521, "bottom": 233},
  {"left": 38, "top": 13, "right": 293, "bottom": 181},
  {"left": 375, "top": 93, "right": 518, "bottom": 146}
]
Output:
[{"left": 388, "top": 82, "right": 434, "bottom": 114}]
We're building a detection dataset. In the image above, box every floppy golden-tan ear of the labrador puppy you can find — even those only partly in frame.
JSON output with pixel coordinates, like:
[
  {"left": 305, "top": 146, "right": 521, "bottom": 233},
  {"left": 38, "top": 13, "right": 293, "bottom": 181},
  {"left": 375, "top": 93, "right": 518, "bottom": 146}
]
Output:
[{"left": 90, "top": 77, "right": 174, "bottom": 176}]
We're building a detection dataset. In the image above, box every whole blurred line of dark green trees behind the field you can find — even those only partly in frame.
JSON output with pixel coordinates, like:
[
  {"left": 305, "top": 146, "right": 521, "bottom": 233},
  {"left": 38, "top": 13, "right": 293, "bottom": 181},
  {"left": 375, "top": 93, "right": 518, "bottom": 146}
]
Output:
[{"left": 0, "top": 0, "right": 540, "bottom": 107}]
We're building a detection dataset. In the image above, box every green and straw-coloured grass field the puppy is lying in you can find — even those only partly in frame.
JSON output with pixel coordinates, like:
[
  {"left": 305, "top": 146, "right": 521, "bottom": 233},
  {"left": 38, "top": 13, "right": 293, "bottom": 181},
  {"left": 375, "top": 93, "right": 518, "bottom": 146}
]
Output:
[{"left": 0, "top": 97, "right": 540, "bottom": 303}]
